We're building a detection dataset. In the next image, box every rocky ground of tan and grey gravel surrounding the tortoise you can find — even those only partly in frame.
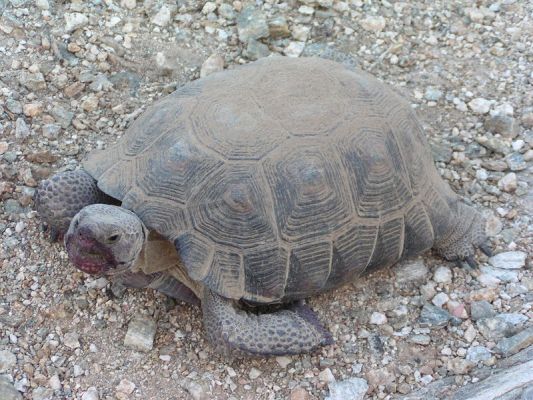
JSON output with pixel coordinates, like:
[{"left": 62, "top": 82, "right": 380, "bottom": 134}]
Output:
[{"left": 0, "top": 0, "right": 533, "bottom": 400}]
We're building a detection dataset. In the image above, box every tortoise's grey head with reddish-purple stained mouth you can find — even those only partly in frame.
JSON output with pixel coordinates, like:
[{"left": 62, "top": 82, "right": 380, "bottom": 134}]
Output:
[{"left": 65, "top": 204, "right": 147, "bottom": 275}]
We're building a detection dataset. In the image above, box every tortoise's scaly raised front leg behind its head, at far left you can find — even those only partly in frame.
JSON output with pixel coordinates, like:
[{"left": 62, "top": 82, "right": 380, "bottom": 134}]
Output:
[{"left": 35, "top": 169, "right": 116, "bottom": 241}]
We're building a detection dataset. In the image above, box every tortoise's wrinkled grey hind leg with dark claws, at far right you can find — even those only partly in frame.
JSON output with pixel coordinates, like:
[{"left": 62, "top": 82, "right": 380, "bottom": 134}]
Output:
[{"left": 434, "top": 201, "right": 492, "bottom": 268}]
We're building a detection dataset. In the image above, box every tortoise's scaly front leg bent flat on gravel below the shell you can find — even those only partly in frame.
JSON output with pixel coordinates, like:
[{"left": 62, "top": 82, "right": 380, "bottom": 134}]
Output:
[{"left": 202, "top": 288, "right": 332, "bottom": 356}]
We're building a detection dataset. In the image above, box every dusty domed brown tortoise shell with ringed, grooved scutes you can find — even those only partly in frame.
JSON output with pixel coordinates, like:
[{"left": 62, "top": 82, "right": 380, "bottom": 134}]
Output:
[{"left": 84, "top": 57, "right": 453, "bottom": 303}]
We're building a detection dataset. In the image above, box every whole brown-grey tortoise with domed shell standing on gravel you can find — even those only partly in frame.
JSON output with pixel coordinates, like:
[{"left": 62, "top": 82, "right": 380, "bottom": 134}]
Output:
[{"left": 36, "top": 57, "right": 490, "bottom": 355}]
